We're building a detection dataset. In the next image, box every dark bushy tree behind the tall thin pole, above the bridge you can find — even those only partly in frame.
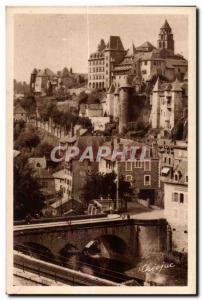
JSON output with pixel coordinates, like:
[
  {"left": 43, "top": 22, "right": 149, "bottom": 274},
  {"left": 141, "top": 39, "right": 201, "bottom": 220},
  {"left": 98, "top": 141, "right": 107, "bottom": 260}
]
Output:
[{"left": 83, "top": 172, "right": 133, "bottom": 204}]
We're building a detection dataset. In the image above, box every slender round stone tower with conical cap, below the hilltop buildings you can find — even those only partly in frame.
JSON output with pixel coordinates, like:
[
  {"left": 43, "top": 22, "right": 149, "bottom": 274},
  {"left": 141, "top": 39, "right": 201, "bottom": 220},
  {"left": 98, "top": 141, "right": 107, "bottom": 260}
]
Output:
[{"left": 119, "top": 77, "right": 132, "bottom": 133}]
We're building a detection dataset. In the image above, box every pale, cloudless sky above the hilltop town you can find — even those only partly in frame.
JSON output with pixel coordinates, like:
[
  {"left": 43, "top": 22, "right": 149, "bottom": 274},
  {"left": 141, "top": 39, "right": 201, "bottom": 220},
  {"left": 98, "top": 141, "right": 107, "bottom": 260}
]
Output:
[{"left": 14, "top": 14, "right": 188, "bottom": 82}]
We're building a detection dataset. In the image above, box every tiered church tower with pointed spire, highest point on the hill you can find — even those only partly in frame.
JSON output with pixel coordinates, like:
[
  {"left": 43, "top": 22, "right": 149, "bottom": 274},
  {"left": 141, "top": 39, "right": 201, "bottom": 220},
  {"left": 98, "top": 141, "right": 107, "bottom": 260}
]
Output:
[{"left": 158, "top": 20, "right": 174, "bottom": 57}]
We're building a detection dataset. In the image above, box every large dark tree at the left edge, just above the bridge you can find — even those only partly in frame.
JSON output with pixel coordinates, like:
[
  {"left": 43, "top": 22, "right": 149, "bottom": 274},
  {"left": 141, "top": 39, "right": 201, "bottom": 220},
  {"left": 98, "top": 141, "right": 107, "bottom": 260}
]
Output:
[{"left": 14, "top": 155, "right": 45, "bottom": 220}]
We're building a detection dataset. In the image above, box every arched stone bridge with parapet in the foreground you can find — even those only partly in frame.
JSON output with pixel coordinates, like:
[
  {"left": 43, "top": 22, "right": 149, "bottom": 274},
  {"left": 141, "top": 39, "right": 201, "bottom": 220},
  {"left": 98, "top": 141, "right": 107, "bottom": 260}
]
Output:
[{"left": 14, "top": 218, "right": 167, "bottom": 261}]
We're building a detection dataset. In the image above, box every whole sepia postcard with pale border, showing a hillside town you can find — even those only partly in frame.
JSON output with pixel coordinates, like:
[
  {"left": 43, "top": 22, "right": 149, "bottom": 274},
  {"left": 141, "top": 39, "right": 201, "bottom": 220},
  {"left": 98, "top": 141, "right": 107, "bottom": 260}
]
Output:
[{"left": 6, "top": 6, "right": 197, "bottom": 295}]
